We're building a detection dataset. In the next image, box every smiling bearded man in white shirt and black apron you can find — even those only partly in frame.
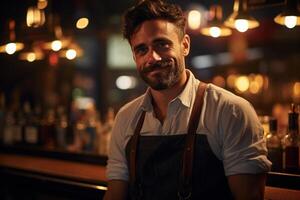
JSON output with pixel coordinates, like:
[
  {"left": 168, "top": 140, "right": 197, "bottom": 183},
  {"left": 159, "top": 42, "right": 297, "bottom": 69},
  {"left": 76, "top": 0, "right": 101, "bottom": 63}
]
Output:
[{"left": 105, "top": 0, "right": 270, "bottom": 200}]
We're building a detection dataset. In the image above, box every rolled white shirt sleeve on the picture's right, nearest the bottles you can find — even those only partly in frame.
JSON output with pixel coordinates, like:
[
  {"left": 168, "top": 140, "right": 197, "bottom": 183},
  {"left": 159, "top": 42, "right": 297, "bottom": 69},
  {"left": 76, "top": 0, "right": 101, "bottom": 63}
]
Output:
[{"left": 219, "top": 98, "right": 271, "bottom": 176}]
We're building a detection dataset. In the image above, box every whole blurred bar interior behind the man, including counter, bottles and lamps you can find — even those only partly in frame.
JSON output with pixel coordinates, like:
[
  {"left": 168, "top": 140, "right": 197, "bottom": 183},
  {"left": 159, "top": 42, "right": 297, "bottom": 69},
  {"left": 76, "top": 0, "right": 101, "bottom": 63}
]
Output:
[{"left": 0, "top": 0, "right": 300, "bottom": 199}]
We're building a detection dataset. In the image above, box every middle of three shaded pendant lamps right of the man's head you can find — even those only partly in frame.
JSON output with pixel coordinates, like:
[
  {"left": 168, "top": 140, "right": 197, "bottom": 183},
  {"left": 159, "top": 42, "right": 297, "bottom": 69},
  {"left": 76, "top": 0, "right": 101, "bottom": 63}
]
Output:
[{"left": 225, "top": 0, "right": 259, "bottom": 32}]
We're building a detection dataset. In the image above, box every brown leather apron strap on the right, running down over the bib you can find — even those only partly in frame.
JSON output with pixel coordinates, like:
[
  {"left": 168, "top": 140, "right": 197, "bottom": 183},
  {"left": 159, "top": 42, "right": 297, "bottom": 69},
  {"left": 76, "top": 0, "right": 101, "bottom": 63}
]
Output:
[{"left": 178, "top": 82, "right": 207, "bottom": 199}]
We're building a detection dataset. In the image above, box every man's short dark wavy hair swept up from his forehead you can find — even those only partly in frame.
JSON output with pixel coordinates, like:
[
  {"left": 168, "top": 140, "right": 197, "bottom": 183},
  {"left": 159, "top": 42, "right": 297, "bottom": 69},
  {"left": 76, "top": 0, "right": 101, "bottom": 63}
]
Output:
[{"left": 123, "top": 0, "right": 186, "bottom": 42}]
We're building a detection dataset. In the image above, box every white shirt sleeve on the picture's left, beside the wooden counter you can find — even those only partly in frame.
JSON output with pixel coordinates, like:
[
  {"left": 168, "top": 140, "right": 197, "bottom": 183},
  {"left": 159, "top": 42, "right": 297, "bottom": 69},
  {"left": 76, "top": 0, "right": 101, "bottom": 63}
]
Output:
[{"left": 106, "top": 113, "right": 129, "bottom": 181}]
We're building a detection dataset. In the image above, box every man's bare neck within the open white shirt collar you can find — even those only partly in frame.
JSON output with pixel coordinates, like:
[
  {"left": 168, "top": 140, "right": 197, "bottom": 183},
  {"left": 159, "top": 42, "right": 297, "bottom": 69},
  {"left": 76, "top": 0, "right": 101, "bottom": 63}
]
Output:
[{"left": 150, "top": 71, "right": 188, "bottom": 124}]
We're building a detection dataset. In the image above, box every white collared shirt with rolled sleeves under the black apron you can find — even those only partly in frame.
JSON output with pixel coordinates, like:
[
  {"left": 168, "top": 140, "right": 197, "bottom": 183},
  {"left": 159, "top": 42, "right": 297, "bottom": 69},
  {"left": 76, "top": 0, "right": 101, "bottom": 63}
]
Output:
[{"left": 107, "top": 70, "right": 271, "bottom": 180}]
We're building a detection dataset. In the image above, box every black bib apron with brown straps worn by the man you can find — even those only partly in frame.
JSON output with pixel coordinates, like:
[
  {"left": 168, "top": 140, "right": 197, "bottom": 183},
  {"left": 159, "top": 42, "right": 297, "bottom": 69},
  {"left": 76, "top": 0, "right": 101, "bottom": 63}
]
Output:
[{"left": 126, "top": 83, "right": 233, "bottom": 200}]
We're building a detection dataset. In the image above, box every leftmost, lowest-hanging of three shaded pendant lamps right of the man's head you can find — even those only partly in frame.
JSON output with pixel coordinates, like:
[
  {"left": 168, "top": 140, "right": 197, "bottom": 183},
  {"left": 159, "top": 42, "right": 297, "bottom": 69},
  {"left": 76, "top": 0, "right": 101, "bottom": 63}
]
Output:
[{"left": 201, "top": 5, "right": 231, "bottom": 38}]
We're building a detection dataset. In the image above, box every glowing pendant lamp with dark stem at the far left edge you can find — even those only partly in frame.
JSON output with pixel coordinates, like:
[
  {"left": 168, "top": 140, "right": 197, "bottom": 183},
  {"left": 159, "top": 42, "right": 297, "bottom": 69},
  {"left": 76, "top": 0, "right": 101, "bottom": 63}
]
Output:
[{"left": 0, "top": 20, "right": 24, "bottom": 55}]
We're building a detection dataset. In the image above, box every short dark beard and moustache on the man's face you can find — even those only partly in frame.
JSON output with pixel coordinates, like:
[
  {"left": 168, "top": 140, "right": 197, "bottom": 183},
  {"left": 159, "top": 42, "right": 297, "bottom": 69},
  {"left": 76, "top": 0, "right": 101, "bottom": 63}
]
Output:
[{"left": 139, "top": 58, "right": 184, "bottom": 90}]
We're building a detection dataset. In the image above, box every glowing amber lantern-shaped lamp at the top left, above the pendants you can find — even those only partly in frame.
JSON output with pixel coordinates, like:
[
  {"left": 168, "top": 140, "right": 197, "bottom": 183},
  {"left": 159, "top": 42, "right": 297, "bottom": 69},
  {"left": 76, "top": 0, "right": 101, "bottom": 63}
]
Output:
[{"left": 26, "top": 7, "right": 45, "bottom": 28}]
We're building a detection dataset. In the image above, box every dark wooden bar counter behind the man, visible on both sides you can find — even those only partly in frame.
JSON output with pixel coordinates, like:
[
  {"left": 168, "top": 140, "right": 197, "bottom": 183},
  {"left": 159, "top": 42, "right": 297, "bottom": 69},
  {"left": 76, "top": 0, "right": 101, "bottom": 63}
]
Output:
[{"left": 0, "top": 153, "right": 300, "bottom": 200}]
